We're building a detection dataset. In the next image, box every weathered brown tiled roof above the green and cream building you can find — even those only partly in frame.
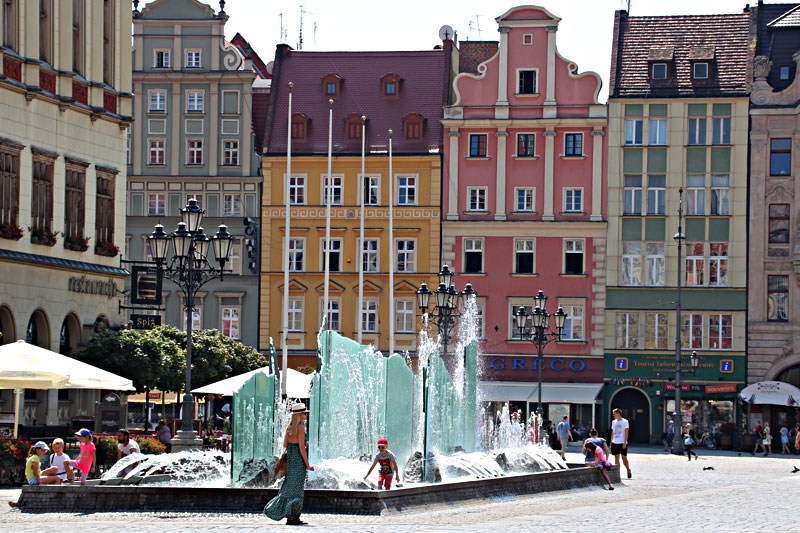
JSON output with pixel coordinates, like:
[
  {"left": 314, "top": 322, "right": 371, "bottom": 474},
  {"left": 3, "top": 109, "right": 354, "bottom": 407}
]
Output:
[{"left": 609, "top": 10, "right": 752, "bottom": 98}]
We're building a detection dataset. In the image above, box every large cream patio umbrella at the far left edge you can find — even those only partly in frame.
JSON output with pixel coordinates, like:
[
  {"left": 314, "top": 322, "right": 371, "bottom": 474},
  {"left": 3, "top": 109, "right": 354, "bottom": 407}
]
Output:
[{"left": 0, "top": 340, "right": 135, "bottom": 437}]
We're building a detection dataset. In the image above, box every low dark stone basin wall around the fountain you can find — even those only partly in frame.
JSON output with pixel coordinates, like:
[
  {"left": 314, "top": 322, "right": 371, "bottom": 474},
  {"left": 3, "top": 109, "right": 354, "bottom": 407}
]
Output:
[{"left": 17, "top": 464, "right": 620, "bottom": 515}]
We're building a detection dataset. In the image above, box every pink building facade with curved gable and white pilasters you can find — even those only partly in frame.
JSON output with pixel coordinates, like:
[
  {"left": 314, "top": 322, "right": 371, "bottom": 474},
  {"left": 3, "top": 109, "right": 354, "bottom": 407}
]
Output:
[{"left": 442, "top": 6, "right": 607, "bottom": 426}]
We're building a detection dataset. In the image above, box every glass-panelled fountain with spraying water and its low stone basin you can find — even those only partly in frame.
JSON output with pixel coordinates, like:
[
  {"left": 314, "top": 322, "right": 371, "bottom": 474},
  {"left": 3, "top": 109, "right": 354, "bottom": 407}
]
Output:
[{"left": 18, "top": 299, "right": 619, "bottom": 513}]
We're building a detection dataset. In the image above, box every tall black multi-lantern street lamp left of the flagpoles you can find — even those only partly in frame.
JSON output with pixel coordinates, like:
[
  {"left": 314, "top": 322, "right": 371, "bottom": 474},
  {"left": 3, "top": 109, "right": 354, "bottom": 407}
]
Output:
[{"left": 147, "top": 198, "right": 233, "bottom": 449}]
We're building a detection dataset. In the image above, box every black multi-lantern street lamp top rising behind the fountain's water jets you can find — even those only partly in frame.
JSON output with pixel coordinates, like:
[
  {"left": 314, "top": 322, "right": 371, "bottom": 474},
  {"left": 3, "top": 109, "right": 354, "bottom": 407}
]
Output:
[{"left": 417, "top": 265, "right": 478, "bottom": 354}]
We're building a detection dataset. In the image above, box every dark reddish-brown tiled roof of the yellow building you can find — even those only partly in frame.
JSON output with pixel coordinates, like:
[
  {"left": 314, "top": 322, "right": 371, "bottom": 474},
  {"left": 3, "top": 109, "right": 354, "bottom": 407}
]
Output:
[{"left": 264, "top": 45, "right": 448, "bottom": 155}]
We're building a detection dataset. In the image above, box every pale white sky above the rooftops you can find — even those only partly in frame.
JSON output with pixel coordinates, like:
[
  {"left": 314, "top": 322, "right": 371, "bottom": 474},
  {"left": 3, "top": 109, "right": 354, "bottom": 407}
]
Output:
[{"left": 162, "top": 0, "right": 752, "bottom": 102}]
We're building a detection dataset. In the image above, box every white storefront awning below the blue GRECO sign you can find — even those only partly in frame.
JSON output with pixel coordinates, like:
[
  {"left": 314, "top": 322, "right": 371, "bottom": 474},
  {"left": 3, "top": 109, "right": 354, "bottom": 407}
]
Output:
[{"left": 478, "top": 381, "right": 603, "bottom": 404}]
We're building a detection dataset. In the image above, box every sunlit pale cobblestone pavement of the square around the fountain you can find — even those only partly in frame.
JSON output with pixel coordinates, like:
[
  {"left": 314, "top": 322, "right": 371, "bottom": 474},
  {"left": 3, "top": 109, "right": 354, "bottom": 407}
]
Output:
[{"left": 0, "top": 445, "right": 800, "bottom": 533}]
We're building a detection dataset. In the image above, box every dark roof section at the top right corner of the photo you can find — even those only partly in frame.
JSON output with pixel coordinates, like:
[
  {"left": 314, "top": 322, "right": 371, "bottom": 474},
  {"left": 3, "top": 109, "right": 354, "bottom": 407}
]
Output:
[{"left": 754, "top": 2, "right": 800, "bottom": 91}]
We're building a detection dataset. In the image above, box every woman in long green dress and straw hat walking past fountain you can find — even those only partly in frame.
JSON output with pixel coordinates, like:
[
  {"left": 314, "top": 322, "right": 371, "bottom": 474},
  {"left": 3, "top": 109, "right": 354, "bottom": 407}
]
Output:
[{"left": 264, "top": 402, "right": 314, "bottom": 526}]
